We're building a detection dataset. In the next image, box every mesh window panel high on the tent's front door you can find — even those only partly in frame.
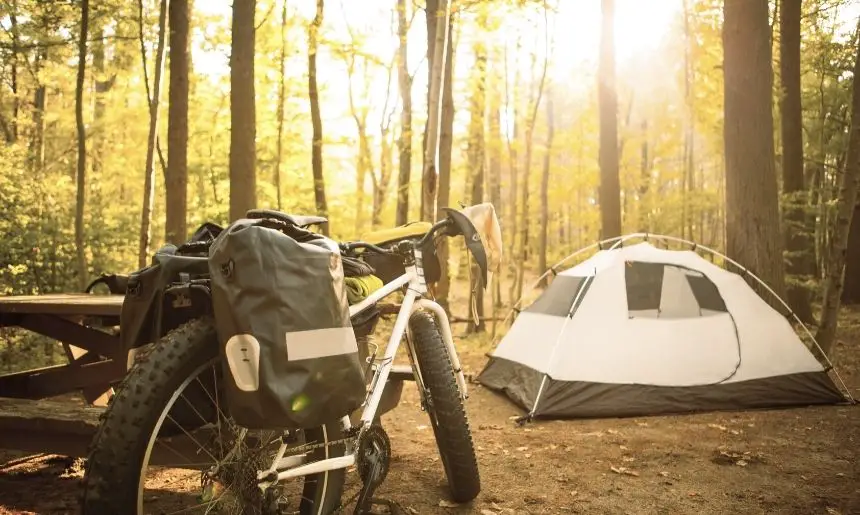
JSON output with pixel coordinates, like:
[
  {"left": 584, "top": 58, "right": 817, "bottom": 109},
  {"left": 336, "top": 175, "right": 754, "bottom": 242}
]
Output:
[{"left": 624, "top": 261, "right": 727, "bottom": 318}]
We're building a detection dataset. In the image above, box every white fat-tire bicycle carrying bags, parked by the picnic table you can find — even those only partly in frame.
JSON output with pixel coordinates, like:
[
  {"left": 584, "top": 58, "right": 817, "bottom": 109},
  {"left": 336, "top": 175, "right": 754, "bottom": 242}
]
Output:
[{"left": 81, "top": 208, "right": 498, "bottom": 515}]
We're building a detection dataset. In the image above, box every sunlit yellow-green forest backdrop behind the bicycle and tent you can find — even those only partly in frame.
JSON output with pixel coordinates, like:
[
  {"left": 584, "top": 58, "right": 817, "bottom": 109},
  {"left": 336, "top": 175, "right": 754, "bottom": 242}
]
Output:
[{"left": 0, "top": 0, "right": 860, "bottom": 362}]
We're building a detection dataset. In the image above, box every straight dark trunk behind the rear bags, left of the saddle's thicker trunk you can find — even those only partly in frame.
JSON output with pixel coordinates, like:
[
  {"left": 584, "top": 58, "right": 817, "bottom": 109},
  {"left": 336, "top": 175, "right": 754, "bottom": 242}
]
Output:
[{"left": 164, "top": 0, "right": 189, "bottom": 245}]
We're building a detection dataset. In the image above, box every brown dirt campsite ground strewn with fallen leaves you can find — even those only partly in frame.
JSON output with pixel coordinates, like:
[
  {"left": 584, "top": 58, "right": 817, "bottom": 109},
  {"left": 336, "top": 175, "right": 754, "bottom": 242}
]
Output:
[{"left": 0, "top": 284, "right": 860, "bottom": 515}]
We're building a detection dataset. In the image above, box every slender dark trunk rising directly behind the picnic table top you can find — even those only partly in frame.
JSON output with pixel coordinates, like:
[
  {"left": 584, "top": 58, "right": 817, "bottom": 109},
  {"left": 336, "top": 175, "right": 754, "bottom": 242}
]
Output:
[{"left": 75, "top": 0, "right": 90, "bottom": 291}]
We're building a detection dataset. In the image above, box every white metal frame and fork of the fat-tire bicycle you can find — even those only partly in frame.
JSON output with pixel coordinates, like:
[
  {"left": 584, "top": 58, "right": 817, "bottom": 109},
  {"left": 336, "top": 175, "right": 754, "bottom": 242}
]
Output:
[{"left": 257, "top": 249, "right": 467, "bottom": 489}]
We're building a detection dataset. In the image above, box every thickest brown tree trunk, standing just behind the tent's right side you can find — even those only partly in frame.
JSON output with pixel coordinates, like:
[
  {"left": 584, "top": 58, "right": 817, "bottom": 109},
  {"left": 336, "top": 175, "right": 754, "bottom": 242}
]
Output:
[{"left": 723, "top": 0, "right": 785, "bottom": 306}]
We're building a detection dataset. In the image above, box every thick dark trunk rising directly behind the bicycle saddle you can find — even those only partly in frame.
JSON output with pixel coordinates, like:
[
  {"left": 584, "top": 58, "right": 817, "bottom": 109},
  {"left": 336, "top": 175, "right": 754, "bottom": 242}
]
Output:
[{"left": 230, "top": 0, "right": 255, "bottom": 221}]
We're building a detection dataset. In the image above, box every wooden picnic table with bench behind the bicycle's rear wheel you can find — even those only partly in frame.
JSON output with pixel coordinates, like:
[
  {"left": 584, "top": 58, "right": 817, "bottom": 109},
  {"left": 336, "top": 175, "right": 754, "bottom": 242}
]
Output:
[{"left": 0, "top": 293, "right": 127, "bottom": 456}]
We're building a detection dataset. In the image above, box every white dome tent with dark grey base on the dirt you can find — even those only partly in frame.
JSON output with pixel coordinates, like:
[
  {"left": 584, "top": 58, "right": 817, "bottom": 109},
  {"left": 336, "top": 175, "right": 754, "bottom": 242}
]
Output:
[{"left": 478, "top": 235, "right": 850, "bottom": 418}]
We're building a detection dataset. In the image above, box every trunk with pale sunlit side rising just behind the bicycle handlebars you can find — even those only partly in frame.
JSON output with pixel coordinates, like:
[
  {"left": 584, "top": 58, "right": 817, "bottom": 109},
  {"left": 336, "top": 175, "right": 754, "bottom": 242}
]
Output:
[{"left": 421, "top": 0, "right": 449, "bottom": 222}]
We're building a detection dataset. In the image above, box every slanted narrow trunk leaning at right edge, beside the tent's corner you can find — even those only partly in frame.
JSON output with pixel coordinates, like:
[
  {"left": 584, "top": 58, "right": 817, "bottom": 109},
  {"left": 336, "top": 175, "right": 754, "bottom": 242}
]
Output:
[{"left": 815, "top": 26, "right": 860, "bottom": 354}]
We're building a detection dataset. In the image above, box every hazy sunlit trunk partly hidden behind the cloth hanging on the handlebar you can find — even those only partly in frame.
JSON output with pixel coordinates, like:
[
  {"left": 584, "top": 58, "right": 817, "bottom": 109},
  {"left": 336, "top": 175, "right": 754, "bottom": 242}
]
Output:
[{"left": 463, "top": 40, "right": 487, "bottom": 333}]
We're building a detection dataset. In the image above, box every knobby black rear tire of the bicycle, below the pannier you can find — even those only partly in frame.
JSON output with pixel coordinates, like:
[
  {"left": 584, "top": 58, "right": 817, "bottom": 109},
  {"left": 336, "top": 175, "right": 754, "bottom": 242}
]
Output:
[{"left": 80, "top": 317, "right": 344, "bottom": 515}]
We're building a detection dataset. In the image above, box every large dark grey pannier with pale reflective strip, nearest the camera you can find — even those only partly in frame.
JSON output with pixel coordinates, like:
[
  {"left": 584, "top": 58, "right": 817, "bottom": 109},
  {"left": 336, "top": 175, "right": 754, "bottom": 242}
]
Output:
[{"left": 209, "top": 219, "right": 365, "bottom": 429}]
